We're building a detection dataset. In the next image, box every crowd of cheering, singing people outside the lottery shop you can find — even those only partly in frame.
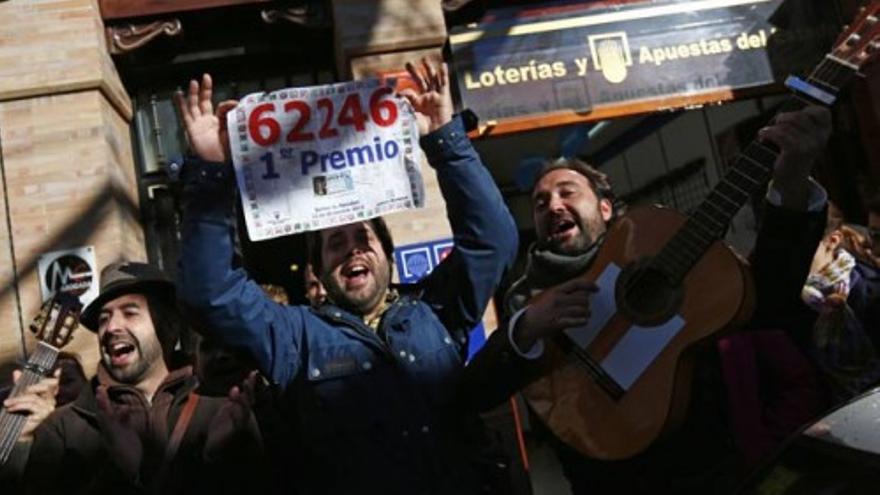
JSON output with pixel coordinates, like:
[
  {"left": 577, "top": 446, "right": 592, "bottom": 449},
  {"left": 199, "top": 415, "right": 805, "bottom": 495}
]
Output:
[{"left": 0, "top": 56, "right": 880, "bottom": 494}]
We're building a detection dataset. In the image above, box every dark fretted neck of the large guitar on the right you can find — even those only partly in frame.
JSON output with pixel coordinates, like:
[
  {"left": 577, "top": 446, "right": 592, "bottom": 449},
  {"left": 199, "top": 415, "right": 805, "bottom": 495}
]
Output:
[{"left": 655, "top": 55, "right": 856, "bottom": 283}]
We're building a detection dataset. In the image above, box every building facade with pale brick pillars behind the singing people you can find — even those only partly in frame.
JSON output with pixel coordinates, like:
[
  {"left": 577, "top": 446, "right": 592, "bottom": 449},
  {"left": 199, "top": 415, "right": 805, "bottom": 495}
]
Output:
[{"left": 0, "top": 0, "right": 880, "bottom": 384}]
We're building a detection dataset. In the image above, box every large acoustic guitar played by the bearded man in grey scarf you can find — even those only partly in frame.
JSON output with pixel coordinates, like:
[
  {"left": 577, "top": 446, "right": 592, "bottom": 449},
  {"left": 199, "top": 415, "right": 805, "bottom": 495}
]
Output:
[{"left": 524, "top": 0, "right": 880, "bottom": 460}]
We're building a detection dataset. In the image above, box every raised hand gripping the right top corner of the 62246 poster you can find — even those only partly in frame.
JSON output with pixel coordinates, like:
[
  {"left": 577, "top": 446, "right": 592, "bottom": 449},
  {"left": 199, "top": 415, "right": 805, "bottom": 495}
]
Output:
[{"left": 400, "top": 58, "right": 454, "bottom": 136}]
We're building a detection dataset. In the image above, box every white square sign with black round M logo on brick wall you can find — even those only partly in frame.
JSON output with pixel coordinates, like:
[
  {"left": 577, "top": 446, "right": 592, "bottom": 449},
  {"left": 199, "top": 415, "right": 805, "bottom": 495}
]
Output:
[{"left": 37, "top": 246, "right": 98, "bottom": 306}]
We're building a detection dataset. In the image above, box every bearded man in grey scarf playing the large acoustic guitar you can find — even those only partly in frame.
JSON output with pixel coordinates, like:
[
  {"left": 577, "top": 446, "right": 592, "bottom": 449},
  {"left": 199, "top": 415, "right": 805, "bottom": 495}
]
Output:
[{"left": 467, "top": 107, "right": 831, "bottom": 494}]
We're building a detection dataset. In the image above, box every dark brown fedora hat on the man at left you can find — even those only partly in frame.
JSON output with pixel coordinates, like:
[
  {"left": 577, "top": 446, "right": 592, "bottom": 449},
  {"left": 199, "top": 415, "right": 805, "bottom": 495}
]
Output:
[{"left": 79, "top": 261, "right": 174, "bottom": 332}]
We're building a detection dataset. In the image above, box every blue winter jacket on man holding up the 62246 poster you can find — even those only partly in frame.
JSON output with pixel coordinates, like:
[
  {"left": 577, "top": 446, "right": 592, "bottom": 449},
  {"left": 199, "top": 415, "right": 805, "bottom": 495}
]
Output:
[{"left": 178, "top": 117, "right": 517, "bottom": 495}]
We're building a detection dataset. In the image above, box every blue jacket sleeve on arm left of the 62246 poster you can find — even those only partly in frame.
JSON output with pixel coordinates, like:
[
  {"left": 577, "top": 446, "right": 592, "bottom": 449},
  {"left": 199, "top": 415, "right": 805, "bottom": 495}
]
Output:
[{"left": 177, "top": 161, "right": 304, "bottom": 385}]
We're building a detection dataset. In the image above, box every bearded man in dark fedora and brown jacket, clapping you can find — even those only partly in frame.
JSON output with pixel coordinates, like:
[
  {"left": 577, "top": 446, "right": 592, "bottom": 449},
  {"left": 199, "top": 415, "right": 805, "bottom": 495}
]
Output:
[{"left": 24, "top": 262, "right": 268, "bottom": 494}]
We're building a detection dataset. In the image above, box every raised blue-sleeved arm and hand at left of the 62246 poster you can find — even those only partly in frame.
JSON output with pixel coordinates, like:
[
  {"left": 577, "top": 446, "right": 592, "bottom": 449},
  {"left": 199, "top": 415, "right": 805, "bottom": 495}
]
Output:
[{"left": 177, "top": 75, "right": 303, "bottom": 384}]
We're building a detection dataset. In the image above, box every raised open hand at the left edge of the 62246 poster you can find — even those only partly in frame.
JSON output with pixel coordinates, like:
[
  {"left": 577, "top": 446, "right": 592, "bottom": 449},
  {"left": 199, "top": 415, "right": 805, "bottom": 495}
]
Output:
[{"left": 174, "top": 74, "right": 238, "bottom": 162}]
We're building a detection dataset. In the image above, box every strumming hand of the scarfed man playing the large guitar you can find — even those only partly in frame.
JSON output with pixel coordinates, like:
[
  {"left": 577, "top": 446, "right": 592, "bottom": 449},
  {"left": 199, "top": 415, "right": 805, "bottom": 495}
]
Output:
[{"left": 513, "top": 278, "right": 598, "bottom": 351}]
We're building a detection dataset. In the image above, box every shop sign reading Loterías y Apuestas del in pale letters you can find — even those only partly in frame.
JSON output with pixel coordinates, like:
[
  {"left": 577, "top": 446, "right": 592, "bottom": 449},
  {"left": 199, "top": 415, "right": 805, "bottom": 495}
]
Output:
[{"left": 450, "top": 0, "right": 834, "bottom": 122}]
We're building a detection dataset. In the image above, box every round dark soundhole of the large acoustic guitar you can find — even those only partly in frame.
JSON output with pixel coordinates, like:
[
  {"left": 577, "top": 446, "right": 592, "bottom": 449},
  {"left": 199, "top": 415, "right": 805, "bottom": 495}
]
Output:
[{"left": 614, "top": 259, "right": 684, "bottom": 327}]
